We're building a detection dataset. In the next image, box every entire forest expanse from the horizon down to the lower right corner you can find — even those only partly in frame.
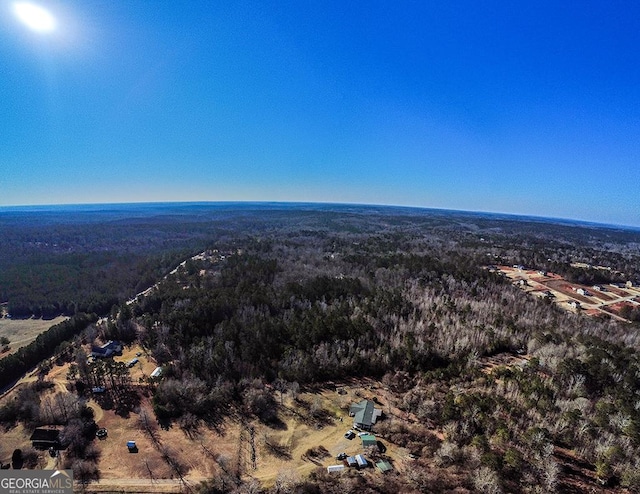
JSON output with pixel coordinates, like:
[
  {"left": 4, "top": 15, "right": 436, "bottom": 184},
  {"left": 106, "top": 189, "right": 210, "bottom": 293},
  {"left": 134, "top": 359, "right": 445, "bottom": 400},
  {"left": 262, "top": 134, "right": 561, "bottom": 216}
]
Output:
[{"left": 0, "top": 206, "right": 640, "bottom": 493}]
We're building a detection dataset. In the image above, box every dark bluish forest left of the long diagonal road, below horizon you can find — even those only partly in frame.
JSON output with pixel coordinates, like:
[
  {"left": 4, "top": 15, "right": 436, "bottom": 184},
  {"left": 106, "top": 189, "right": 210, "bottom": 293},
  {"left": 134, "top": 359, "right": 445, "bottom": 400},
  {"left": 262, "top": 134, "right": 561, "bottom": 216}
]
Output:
[{"left": 0, "top": 205, "right": 225, "bottom": 318}]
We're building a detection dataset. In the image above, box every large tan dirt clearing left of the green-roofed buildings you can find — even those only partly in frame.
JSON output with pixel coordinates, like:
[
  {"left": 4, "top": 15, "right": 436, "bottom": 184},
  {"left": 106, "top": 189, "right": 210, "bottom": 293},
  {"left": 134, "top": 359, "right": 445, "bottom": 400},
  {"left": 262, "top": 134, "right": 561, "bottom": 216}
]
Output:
[{"left": 89, "top": 380, "right": 407, "bottom": 491}]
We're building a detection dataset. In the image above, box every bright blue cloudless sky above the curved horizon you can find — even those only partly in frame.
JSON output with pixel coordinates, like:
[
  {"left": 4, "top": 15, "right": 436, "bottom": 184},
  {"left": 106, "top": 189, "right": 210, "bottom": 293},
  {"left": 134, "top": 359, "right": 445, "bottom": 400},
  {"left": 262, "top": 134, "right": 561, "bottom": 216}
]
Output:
[{"left": 0, "top": 0, "right": 640, "bottom": 226}]
